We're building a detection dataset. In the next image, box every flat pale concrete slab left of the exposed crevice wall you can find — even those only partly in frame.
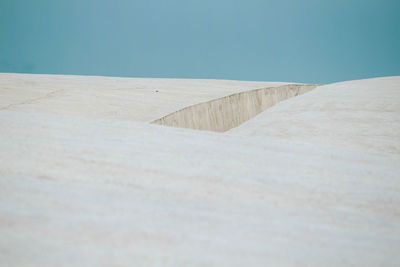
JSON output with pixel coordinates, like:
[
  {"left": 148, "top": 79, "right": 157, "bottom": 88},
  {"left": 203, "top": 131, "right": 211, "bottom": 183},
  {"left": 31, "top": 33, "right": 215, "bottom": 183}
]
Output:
[{"left": 0, "top": 73, "right": 287, "bottom": 122}]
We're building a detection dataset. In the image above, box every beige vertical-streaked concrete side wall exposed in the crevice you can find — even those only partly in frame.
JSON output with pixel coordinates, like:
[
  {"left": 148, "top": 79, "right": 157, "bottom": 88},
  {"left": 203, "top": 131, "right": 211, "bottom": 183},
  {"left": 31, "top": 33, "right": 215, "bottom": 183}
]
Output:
[{"left": 152, "top": 84, "right": 317, "bottom": 132}]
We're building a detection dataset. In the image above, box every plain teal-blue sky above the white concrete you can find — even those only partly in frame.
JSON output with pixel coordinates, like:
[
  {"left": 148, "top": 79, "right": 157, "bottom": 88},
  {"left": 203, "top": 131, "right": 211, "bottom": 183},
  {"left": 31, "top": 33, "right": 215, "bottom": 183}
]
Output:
[{"left": 0, "top": 0, "right": 400, "bottom": 83}]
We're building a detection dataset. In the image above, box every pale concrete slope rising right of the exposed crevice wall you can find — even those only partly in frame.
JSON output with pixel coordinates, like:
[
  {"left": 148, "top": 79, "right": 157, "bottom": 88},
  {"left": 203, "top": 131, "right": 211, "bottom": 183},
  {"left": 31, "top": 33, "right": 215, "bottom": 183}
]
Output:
[{"left": 229, "top": 76, "right": 400, "bottom": 154}]
